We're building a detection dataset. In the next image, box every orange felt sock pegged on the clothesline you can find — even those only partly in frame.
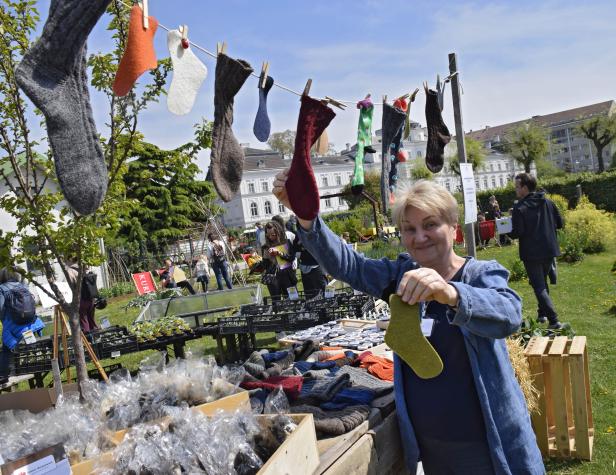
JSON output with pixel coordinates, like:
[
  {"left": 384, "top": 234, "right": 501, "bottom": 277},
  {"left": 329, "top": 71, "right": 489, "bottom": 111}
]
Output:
[{"left": 113, "top": 5, "right": 158, "bottom": 97}]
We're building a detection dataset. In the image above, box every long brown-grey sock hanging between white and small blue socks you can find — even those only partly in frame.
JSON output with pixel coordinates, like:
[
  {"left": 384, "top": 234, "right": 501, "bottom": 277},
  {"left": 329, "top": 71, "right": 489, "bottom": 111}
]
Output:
[{"left": 210, "top": 54, "right": 252, "bottom": 202}]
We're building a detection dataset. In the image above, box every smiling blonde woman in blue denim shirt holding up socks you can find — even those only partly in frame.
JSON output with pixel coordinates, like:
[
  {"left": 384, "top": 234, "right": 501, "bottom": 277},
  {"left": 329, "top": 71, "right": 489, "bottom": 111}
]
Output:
[{"left": 274, "top": 171, "right": 545, "bottom": 475}]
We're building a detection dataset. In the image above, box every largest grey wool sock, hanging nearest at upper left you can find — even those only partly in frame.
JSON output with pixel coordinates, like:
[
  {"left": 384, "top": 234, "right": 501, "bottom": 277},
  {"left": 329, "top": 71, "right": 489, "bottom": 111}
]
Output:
[{"left": 16, "top": 0, "right": 110, "bottom": 215}]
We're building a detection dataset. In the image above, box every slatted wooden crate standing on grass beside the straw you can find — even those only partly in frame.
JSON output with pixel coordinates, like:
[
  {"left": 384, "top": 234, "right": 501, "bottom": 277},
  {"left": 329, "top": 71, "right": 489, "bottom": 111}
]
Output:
[{"left": 524, "top": 336, "right": 594, "bottom": 460}]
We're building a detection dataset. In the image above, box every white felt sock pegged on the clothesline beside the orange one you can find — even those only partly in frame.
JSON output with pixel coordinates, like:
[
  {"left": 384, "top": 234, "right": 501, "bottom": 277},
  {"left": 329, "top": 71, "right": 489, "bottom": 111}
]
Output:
[{"left": 167, "top": 30, "right": 207, "bottom": 115}]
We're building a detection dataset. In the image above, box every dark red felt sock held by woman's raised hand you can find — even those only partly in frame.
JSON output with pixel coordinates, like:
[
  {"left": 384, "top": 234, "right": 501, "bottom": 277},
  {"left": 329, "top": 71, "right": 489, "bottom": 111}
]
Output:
[{"left": 286, "top": 95, "right": 336, "bottom": 220}]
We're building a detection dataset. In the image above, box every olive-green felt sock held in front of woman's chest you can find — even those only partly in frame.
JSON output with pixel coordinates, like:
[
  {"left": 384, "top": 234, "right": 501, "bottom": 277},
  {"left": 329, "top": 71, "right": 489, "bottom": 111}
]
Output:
[{"left": 385, "top": 294, "right": 443, "bottom": 379}]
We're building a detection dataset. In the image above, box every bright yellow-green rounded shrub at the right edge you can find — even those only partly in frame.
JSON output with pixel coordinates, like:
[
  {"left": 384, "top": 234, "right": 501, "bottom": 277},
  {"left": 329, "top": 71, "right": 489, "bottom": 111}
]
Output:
[{"left": 566, "top": 196, "right": 614, "bottom": 254}]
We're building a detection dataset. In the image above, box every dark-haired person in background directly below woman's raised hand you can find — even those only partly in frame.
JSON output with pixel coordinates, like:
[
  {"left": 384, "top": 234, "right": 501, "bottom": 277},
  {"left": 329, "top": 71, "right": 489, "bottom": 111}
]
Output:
[{"left": 262, "top": 220, "right": 297, "bottom": 299}]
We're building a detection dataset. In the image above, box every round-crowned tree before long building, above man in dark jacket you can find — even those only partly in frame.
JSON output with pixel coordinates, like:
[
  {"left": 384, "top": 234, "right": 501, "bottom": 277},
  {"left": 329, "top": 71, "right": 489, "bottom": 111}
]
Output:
[{"left": 501, "top": 122, "right": 549, "bottom": 173}]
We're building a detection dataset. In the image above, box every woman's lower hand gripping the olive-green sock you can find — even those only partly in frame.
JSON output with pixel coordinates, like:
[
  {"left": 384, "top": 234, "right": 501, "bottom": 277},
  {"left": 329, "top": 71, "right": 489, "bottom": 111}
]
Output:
[{"left": 396, "top": 267, "right": 458, "bottom": 307}]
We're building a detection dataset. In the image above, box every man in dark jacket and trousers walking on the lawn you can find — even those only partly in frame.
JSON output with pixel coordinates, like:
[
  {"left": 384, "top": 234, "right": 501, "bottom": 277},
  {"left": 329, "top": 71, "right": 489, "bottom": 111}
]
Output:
[{"left": 510, "top": 173, "right": 563, "bottom": 329}]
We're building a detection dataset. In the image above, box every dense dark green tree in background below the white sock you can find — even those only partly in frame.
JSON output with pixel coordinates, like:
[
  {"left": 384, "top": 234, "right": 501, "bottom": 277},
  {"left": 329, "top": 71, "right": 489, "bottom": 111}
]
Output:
[{"left": 119, "top": 128, "right": 214, "bottom": 257}]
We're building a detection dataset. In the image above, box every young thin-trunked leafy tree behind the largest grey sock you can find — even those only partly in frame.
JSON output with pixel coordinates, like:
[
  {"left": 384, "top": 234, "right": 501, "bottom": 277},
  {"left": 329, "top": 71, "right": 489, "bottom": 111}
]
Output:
[{"left": 0, "top": 0, "right": 171, "bottom": 390}]
